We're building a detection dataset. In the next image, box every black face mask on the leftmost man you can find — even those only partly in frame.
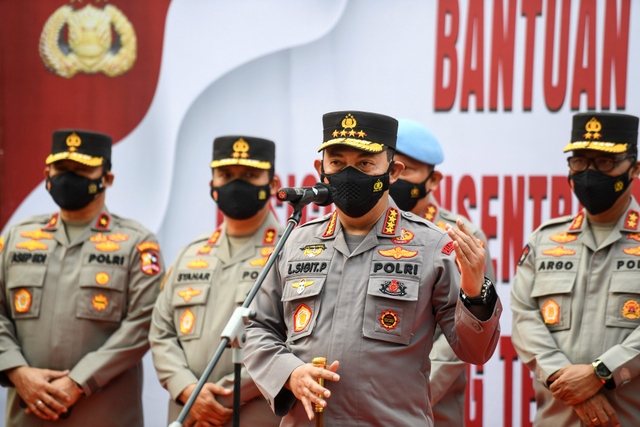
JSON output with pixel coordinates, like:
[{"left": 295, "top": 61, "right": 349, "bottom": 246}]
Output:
[{"left": 45, "top": 172, "right": 104, "bottom": 211}]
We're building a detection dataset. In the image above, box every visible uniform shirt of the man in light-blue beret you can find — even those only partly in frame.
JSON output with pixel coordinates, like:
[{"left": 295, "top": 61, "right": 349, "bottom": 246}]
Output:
[{"left": 422, "top": 195, "right": 496, "bottom": 427}]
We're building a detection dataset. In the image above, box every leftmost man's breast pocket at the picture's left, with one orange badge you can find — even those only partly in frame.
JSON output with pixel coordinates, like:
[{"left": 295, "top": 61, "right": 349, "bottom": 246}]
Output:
[{"left": 7, "top": 265, "right": 47, "bottom": 320}]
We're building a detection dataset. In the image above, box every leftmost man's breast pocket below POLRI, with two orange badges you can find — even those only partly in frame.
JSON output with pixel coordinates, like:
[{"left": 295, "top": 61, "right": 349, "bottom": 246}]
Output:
[{"left": 76, "top": 267, "right": 127, "bottom": 322}]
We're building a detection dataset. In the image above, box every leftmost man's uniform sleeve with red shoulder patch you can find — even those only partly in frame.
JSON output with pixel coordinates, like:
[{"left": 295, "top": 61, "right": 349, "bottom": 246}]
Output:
[{"left": 69, "top": 234, "right": 164, "bottom": 396}]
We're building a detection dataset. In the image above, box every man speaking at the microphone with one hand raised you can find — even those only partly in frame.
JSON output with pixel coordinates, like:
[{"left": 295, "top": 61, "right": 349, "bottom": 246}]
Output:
[{"left": 245, "top": 111, "right": 501, "bottom": 426}]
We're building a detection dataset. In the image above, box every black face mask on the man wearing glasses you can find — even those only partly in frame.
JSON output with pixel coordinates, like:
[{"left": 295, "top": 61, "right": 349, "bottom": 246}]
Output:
[{"left": 569, "top": 168, "right": 631, "bottom": 215}]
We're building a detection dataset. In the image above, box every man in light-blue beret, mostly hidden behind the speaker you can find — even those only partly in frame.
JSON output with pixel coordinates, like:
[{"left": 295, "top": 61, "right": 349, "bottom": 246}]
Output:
[{"left": 389, "top": 119, "right": 495, "bottom": 427}]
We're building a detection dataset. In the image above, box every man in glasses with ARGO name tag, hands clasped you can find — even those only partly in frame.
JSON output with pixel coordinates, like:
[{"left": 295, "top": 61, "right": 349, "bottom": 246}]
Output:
[{"left": 511, "top": 113, "right": 640, "bottom": 427}]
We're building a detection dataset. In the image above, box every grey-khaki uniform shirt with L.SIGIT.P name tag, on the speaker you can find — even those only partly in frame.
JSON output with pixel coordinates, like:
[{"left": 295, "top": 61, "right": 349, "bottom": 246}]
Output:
[{"left": 245, "top": 200, "right": 501, "bottom": 427}]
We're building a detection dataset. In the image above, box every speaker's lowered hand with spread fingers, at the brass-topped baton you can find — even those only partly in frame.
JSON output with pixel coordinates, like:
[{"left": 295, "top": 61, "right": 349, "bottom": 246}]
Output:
[{"left": 285, "top": 360, "right": 340, "bottom": 420}]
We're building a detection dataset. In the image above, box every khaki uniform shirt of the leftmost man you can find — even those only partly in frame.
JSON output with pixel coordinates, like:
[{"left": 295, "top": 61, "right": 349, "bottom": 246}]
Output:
[{"left": 0, "top": 208, "right": 164, "bottom": 427}]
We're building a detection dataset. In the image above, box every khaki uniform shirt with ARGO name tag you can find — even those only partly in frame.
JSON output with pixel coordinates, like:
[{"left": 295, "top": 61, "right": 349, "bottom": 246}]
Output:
[{"left": 511, "top": 199, "right": 640, "bottom": 427}]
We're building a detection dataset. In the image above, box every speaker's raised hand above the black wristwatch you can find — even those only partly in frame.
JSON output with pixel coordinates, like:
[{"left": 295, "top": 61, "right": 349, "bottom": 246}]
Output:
[{"left": 447, "top": 218, "right": 485, "bottom": 298}]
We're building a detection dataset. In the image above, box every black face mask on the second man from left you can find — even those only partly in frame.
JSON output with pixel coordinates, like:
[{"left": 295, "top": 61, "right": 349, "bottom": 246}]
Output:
[{"left": 211, "top": 179, "right": 271, "bottom": 219}]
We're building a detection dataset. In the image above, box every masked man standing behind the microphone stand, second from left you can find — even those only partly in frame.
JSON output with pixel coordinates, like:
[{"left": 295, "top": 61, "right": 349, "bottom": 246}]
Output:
[{"left": 149, "top": 136, "right": 283, "bottom": 427}]
